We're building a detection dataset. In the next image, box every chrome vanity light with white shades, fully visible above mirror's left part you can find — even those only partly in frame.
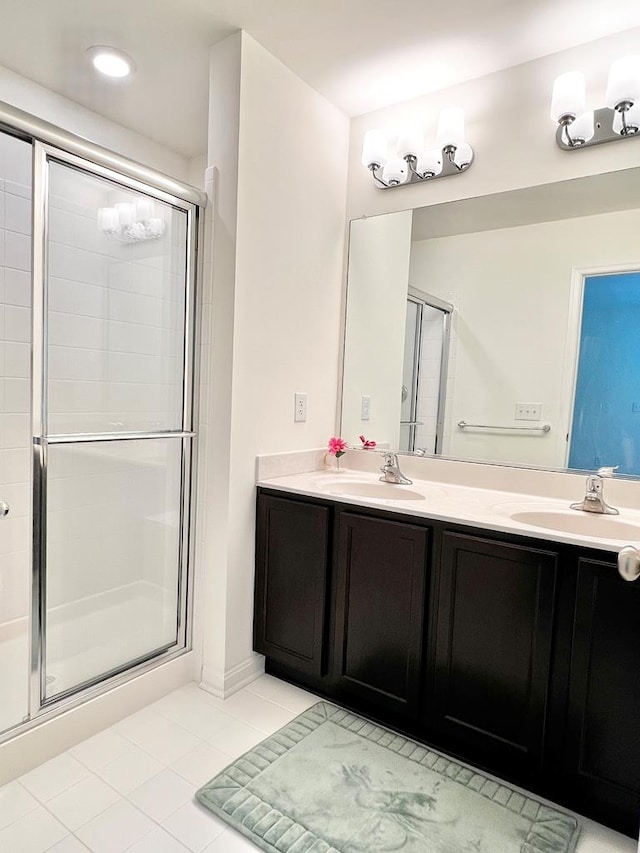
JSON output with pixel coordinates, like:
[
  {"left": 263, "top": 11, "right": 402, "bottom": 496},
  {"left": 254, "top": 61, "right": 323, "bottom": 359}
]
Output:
[{"left": 362, "top": 107, "right": 473, "bottom": 190}]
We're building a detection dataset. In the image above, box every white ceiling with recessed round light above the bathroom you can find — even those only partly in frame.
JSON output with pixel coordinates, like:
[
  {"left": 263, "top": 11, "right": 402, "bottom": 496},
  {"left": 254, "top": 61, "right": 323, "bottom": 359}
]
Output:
[{"left": 0, "top": 0, "right": 640, "bottom": 157}]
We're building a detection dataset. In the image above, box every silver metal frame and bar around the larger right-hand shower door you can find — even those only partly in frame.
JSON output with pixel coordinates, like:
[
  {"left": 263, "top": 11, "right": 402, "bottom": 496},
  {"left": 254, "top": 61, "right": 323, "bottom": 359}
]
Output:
[{"left": 28, "top": 140, "right": 202, "bottom": 726}]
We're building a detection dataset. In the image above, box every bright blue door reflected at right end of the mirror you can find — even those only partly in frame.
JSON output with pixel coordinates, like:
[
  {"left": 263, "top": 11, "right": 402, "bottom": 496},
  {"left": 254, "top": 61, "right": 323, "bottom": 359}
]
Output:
[{"left": 569, "top": 272, "right": 640, "bottom": 474}]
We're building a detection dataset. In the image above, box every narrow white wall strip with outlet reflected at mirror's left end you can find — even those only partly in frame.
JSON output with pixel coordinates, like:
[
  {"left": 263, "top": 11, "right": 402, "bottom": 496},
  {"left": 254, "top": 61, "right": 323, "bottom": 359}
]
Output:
[{"left": 342, "top": 211, "right": 413, "bottom": 447}]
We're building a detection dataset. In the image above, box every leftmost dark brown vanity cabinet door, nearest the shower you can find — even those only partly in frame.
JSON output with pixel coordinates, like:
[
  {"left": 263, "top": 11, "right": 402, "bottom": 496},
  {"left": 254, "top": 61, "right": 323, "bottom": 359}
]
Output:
[{"left": 254, "top": 494, "right": 329, "bottom": 677}]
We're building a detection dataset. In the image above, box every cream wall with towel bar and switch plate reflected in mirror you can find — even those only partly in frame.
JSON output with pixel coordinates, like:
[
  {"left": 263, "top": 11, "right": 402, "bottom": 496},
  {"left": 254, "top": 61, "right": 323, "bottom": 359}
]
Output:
[{"left": 411, "top": 210, "right": 640, "bottom": 468}]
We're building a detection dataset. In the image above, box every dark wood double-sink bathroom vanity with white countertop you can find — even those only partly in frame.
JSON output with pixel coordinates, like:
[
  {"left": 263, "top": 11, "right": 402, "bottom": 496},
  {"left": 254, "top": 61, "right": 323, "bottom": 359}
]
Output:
[{"left": 254, "top": 472, "right": 640, "bottom": 836}]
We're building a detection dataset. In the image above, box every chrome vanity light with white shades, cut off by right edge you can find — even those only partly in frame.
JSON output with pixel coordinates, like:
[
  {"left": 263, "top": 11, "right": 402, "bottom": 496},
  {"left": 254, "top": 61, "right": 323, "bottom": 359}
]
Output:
[{"left": 551, "top": 56, "right": 640, "bottom": 151}]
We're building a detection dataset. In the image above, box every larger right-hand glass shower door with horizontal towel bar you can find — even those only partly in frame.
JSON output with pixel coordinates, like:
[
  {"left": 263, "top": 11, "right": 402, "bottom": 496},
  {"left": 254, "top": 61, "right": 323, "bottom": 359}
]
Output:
[{"left": 34, "top": 149, "right": 193, "bottom": 704}]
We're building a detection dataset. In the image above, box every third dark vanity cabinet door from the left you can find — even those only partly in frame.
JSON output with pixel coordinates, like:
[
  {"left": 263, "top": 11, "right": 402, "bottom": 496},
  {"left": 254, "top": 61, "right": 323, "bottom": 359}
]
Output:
[{"left": 425, "top": 532, "right": 557, "bottom": 777}]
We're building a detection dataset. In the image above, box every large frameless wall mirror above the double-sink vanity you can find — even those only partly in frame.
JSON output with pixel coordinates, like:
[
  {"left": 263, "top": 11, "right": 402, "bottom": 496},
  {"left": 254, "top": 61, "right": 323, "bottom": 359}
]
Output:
[{"left": 341, "top": 163, "right": 640, "bottom": 476}]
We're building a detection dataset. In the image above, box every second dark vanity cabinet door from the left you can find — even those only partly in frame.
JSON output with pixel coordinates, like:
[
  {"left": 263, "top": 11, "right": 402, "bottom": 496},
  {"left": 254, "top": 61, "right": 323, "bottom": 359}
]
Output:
[{"left": 334, "top": 513, "right": 428, "bottom": 716}]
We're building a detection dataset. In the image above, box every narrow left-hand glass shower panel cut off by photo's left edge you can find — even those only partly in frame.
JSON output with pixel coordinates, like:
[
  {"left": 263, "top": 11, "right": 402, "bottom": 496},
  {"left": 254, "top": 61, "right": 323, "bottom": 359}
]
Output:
[{"left": 0, "top": 132, "right": 32, "bottom": 733}]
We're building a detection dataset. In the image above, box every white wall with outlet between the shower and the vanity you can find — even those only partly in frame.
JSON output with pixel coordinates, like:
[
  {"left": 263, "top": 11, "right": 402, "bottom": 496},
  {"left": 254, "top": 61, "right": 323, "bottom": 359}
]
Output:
[{"left": 203, "top": 34, "right": 348, "bottom": 691}]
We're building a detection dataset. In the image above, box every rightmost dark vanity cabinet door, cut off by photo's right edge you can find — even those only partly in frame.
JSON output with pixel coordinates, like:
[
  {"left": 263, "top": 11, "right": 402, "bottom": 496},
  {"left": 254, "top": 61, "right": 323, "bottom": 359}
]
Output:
[{"left": 564, "top": 559, "right": 640, "bottom": 837}]
